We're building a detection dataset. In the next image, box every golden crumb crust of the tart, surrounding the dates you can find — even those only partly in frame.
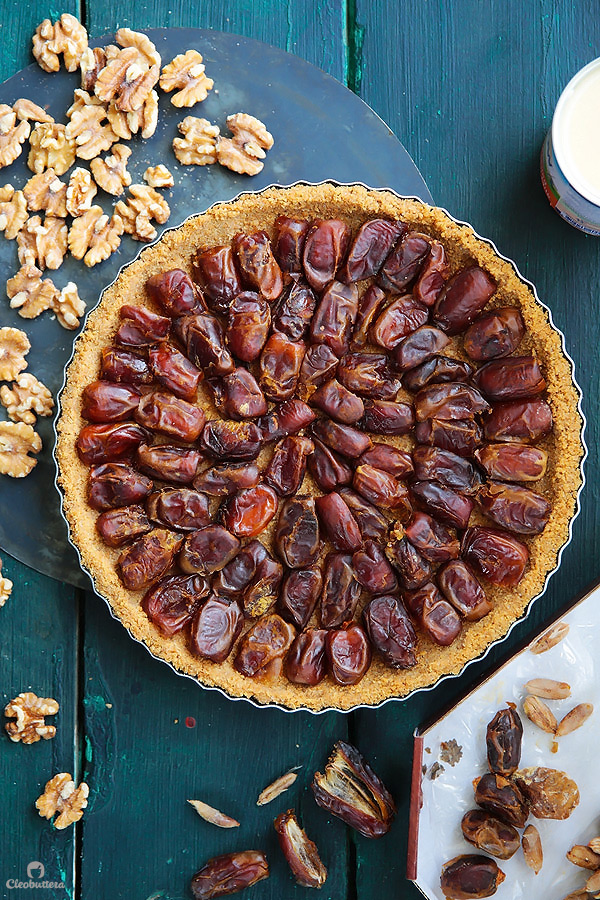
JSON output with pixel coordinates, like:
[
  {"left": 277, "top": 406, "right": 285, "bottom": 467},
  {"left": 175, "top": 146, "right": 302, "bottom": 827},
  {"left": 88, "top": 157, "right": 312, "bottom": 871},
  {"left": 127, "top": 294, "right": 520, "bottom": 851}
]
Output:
[{"left": 56, "top": 183, "right": 584, "bottom": 711}]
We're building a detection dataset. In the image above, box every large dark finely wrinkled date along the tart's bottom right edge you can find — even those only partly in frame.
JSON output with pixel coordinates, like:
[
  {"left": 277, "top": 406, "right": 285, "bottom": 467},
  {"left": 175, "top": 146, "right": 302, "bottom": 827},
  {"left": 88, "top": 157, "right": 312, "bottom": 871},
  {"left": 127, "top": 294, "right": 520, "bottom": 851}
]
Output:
[{"left": 364, "top": 594, "right": 417, "bottom": 669}]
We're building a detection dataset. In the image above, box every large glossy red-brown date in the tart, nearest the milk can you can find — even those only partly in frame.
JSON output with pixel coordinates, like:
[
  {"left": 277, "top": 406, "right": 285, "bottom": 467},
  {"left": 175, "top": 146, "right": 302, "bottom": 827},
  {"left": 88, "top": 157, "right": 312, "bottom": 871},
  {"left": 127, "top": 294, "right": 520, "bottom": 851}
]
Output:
[{"left": 433, "top": 266, "right": 497, "bottom": 335}]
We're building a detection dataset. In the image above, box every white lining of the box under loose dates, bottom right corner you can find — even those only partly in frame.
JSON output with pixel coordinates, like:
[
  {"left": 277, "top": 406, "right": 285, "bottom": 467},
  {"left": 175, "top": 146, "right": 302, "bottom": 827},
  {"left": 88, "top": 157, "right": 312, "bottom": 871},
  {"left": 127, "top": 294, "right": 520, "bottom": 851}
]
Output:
[{"left": 416, "top": 587, "right": 600, "bottom": 900}]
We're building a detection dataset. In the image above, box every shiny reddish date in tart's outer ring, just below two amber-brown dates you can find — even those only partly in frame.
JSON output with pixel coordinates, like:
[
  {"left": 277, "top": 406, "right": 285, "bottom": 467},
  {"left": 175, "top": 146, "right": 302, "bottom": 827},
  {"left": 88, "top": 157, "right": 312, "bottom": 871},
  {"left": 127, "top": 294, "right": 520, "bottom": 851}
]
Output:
[{"left": 462, "top": 526, "right": 529, "bottom": 587}]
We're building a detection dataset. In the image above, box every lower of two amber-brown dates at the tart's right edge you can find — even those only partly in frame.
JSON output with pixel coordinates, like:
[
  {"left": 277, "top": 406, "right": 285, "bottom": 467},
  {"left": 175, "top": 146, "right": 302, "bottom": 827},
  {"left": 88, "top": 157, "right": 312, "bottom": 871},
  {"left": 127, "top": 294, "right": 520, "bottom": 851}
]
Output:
[{"left": 477, "top": 481, "right": 552, "bottom": 534}]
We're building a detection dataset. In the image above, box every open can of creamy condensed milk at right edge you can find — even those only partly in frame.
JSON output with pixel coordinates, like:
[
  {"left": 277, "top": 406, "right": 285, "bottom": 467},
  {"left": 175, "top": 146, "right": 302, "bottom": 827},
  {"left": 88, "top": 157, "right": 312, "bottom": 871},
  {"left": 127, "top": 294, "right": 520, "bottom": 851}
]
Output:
[{"left": 540, "top": 59, "right": 600, "bottom": 235}]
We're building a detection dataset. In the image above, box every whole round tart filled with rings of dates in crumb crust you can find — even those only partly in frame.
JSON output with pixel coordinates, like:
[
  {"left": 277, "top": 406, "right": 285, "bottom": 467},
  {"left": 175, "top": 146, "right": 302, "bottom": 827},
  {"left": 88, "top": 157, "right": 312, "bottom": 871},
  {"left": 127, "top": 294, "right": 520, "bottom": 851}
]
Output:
[{"left": 57, "top": 183, "right": 584, "bottom": 710}]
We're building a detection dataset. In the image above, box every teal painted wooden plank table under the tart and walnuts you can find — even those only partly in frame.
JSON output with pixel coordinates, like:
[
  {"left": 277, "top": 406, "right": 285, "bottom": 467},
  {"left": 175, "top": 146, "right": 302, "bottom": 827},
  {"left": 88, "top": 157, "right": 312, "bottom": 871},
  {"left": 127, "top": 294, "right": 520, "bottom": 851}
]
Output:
[{"left": 0, "top": 0, "right": 600, "bottom": 900}]
